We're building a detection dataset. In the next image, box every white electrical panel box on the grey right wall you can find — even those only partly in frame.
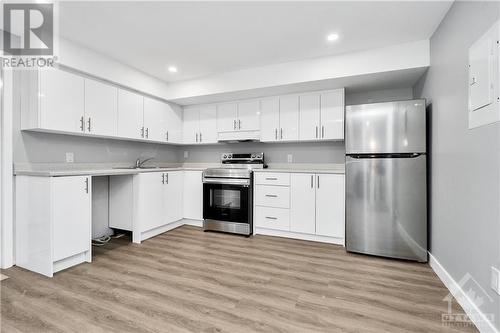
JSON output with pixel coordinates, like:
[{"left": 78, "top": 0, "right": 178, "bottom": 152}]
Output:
[{"left": 468, "top": 22, "right": 500, "bottom": 129}]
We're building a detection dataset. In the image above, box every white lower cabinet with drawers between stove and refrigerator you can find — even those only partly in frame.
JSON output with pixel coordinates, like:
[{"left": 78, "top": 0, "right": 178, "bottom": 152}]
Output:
[{"left": 254, "top": 172, "right": 345, "bottom": 245}]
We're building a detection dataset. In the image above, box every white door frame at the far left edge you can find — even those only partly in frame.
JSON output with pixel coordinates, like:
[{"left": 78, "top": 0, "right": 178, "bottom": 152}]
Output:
[{"left": 0, "top": 69, "right": 14, "bottom": 268}]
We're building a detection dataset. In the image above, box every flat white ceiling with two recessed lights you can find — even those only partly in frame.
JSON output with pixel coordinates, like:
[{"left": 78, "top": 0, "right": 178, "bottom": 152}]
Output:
[{"left": 59, "top": 1, "right": 451, "bottom": 82}]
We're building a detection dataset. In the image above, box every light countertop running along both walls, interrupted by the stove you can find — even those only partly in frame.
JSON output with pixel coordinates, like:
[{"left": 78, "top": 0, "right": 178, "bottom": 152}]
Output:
[{"left": 14, "top": 163, "right": 345, "bottom": 177}]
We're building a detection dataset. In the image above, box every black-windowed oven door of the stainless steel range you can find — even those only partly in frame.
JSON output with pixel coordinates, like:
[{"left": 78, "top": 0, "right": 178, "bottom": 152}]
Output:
[{"left": 203, "top": 179, "right": 251, "bottom": 223}]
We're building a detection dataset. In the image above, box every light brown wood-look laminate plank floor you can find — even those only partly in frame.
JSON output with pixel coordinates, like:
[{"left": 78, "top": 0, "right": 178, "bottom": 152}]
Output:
[{"left": 0, "top": 226, "right": 476, "bottom": 333}]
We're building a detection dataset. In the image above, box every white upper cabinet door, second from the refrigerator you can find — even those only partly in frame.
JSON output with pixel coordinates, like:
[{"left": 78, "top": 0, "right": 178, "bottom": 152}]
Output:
[{"left": 299, "top": 94, "right": 320, "bottom": 140}]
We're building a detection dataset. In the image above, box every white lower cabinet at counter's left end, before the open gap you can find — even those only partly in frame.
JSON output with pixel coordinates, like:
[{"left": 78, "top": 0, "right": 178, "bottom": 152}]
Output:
[{"left": 15, "top": 176, "right": 92, "bottom": 277}]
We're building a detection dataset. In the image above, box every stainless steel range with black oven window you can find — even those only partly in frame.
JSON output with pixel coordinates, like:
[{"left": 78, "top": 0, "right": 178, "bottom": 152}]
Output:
[{"left": 203, "top": 153, "right": 264, "bottom": 236}]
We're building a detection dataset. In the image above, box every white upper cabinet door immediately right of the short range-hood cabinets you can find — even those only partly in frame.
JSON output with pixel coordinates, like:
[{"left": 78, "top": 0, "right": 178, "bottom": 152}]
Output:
[{"left": 260, "top": 97, "right": 280, "bottom": 142}]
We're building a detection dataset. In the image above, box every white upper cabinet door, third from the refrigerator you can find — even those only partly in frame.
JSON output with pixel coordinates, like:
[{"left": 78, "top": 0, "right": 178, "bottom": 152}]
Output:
[{"left": 278, "top": 95, "right": 299, "bottom": 141}]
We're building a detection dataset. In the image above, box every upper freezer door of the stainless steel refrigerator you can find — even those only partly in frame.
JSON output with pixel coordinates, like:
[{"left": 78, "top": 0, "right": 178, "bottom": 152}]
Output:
[{"left": 345, "top": 99, "right": 426, "bottom": 154}]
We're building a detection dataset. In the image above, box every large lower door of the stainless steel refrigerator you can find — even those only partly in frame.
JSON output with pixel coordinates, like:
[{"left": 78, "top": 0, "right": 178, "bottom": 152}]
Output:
[{"left": 346, "top": 155, "right": 427, "bottom": 262}]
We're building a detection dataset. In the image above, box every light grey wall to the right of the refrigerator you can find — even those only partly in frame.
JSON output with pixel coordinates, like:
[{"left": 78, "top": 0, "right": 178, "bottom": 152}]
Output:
[{"left": 415, "top": 1, "right": 500, "bottom": 329}]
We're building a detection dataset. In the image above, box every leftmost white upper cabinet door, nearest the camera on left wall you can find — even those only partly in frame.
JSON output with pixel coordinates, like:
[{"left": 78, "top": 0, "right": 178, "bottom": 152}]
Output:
[{"left": 38, "top": 69, "right": 84, "bottom": 132}]
